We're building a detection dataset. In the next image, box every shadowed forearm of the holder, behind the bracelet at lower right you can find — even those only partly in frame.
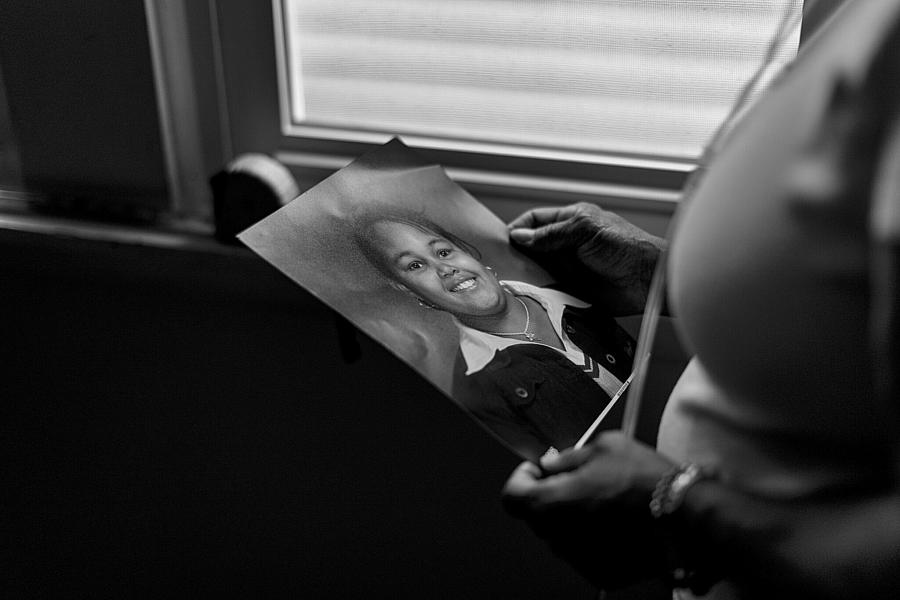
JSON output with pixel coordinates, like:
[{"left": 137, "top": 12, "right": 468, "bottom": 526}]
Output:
[{"left": 673, "top": 481, "right": 900, "bottom": 598}]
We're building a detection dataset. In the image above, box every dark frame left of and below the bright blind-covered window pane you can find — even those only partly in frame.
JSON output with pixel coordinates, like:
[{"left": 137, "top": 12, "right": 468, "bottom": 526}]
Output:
[{"left": 210, "top": 0, "right": 696, "bottom": 214}]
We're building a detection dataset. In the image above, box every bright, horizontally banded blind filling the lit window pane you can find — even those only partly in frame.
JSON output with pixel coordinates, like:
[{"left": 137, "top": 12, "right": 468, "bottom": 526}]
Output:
[{"left": 275, "top": 0, "right": 803, "bottom": 158}]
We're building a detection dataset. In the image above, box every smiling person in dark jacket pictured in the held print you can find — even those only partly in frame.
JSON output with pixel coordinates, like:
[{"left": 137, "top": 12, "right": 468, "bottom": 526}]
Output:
[{"left": 354, "top": 211, "right": 634, "bottom": 456}]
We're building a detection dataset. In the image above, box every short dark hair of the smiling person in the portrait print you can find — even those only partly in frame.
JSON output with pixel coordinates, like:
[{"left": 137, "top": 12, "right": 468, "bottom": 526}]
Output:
[{"left": 352, "top": 209, "right": 481, "bottom": 283}]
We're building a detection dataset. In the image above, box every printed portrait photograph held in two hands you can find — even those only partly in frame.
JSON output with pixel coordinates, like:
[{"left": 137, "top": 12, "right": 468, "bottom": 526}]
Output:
[{"left": 238, "top": 139, "right": 635, "bottom": 462}]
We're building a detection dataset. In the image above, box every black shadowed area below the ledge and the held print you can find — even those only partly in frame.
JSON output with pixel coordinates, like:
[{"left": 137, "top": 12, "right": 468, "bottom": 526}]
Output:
[{"left": 0, "top": 230, "right": 684, "bottom": 598}]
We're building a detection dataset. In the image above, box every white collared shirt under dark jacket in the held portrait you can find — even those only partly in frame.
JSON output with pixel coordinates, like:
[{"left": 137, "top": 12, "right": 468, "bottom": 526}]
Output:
[{"left": 456, "top": 281, "right": 622, "bottom": 396}]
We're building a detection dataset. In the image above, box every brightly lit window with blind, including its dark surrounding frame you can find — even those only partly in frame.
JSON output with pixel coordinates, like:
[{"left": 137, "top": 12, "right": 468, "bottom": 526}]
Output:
[{"left": 210, "top": 0, "right": 803, "bottom": 215}]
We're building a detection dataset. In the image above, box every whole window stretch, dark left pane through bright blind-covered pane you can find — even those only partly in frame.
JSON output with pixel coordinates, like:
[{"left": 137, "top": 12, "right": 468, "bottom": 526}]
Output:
[{"left": 0, "top": 0, "right": 804, "bottom": 223}]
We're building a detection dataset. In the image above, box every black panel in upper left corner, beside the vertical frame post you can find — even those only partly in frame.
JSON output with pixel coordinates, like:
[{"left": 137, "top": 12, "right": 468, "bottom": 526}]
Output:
[{"left": 0, "top": 0, "right": 167, "bottom": 209}]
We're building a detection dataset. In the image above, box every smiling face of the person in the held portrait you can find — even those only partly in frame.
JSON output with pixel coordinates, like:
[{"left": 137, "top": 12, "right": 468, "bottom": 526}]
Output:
[{"left": 375, "top": 221, "right": 506, "bottom": 316}]
